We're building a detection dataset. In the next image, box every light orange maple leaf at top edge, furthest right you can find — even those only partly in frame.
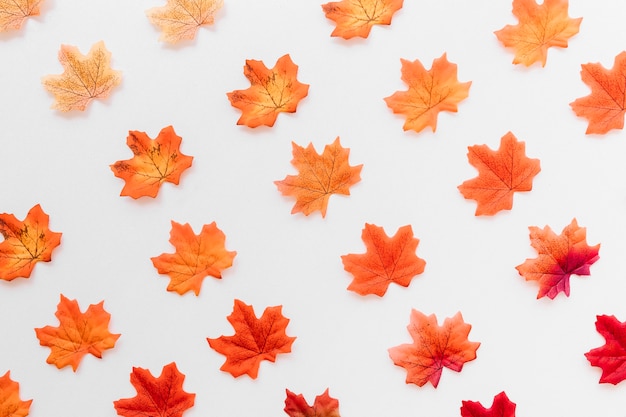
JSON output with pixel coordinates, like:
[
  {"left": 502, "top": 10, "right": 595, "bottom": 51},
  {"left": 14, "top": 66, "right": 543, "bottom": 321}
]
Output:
[{"left": 494, "top": 0, "right": 582, "bottom": 66}]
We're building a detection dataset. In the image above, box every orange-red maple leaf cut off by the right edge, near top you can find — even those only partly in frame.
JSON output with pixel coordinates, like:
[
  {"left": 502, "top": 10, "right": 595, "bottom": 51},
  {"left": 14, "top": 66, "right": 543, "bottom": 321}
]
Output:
[{"left": 570, "top": 52, "right": 626, "bottom": 134}]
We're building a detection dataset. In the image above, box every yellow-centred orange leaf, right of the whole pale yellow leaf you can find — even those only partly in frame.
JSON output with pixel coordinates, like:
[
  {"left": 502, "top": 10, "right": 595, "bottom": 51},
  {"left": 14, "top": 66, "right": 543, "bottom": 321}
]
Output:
[{"left": 226, "top": 54, "right": 309, "bottom": 127}]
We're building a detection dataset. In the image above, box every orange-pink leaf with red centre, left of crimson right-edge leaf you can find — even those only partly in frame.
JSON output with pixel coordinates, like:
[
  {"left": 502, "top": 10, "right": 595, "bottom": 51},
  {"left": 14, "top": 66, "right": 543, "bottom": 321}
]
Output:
[{"left": 389, "top": 310, "right": 480, "bottom": 388}]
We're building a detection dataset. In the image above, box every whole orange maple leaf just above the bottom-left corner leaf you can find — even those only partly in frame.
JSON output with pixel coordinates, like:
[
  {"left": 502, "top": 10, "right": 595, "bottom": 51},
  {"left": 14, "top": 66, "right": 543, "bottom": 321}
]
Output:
[{"left": 35, "top": 294, "right": 120, "bottom": 372}]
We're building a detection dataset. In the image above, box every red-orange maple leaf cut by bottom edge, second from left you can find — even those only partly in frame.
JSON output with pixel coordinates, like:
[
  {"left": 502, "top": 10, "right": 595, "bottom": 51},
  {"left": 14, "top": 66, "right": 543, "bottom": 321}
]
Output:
[{"left": 113, "top": 362, "right": 196, "bottom": 417}]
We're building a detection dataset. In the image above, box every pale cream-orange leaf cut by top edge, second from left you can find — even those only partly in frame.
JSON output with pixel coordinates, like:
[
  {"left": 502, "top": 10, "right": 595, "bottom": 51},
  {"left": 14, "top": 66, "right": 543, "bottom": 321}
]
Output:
[{"left": 146, "top": 0, "right": 224, "bottom": 43}]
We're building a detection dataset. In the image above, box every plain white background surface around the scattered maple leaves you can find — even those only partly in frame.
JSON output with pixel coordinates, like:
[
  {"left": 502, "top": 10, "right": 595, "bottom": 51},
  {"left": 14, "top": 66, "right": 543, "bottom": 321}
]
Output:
[{"left": 0, "top": 0, "right": 626, "bottom": 417}]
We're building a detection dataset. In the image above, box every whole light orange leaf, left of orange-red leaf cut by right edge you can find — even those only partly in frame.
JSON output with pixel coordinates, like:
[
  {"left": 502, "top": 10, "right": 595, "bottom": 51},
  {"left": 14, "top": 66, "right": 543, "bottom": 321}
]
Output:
[{"left": 385, "top": 53, "right": 472, "bottom": 132}]
